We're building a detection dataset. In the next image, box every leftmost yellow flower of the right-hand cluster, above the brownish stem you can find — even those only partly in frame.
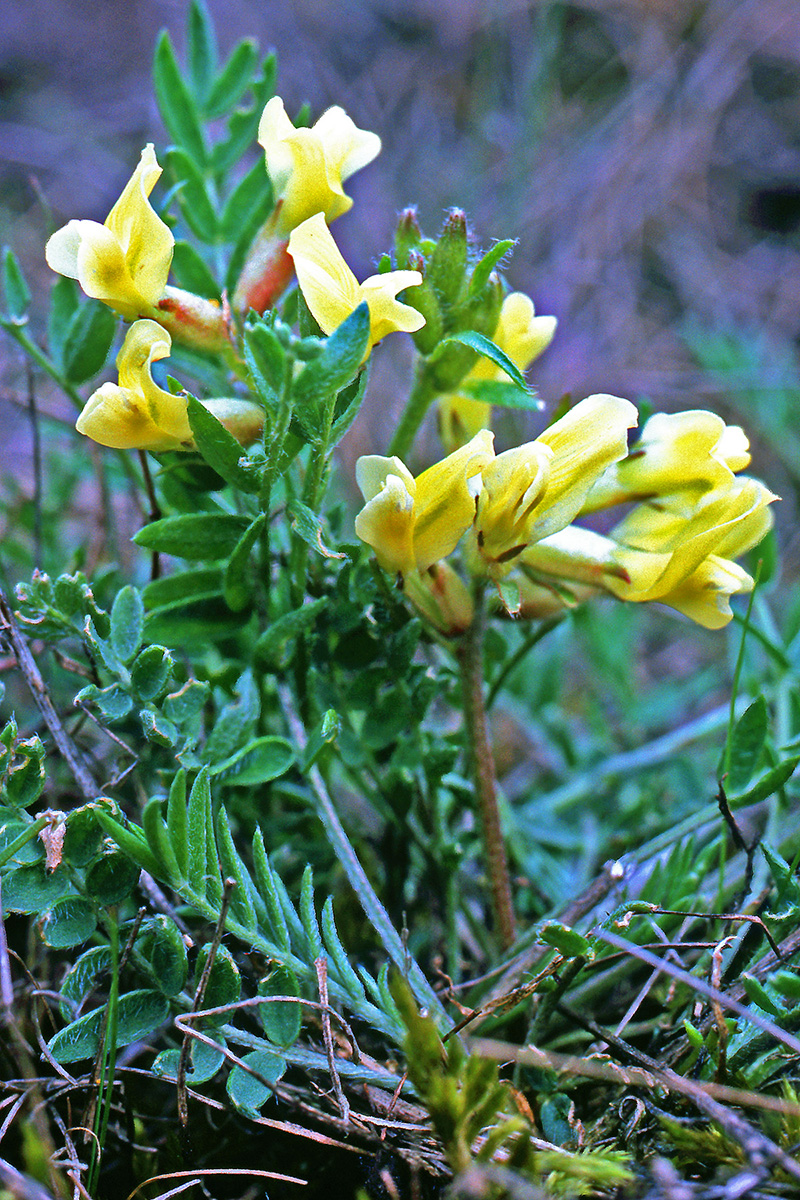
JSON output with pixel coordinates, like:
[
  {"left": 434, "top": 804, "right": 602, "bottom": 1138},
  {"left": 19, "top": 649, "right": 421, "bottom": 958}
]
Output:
[{"left": 355, "top": 430, "right": 494, "bottom": 577}]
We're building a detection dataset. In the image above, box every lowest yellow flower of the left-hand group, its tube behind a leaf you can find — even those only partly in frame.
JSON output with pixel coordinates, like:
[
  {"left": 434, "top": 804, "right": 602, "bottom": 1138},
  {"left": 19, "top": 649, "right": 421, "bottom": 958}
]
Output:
[{"left": 76, "top": 320, "right": 264, "bottom": 451}]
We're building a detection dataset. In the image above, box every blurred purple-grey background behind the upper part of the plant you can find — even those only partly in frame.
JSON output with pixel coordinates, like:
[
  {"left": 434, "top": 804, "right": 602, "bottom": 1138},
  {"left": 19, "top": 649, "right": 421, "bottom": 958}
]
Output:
[{"left": 0, "top": 0, "right": 800, "bottom": 576}]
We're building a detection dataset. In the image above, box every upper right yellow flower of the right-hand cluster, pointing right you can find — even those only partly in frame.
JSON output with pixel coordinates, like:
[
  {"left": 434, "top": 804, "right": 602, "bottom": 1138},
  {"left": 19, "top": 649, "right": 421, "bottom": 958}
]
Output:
[{"left": 584, "top": 409, "right": 750, "bottom": 516}]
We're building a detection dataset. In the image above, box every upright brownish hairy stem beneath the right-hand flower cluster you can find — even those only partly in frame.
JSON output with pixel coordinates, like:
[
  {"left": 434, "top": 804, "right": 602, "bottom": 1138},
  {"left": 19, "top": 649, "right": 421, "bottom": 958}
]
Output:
[{"left": 457, "top": 594, "right": 516, "bottom": 949}]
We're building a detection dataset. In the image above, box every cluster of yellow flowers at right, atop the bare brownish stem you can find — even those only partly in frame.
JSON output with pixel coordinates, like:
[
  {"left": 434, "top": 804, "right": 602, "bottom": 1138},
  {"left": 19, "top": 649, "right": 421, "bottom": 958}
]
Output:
[{"left": 356, "top": 395, "right": 776, "bottom": 634}]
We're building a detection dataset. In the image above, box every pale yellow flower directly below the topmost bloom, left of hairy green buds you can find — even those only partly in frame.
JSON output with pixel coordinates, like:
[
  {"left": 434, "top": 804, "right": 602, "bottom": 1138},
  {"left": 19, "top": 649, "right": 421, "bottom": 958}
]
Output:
[{"left": 289, "top": 212, "right": 425, "bottom": 347}]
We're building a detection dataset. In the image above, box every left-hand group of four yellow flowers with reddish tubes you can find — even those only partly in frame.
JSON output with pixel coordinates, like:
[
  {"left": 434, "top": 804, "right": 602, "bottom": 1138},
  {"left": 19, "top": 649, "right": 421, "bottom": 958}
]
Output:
[{"left": 46, "top": 96, "right": 417, "bottom": 451}]
